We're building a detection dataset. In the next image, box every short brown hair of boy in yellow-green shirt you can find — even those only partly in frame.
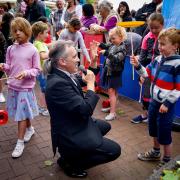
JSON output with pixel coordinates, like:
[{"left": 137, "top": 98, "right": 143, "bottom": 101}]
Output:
[{"left": 32, "top": 21, "right": 49, "bottom": 38}]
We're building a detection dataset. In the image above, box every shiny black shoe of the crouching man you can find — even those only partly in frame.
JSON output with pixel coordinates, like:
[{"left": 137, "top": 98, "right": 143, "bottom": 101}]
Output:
[{"left": 57, "top": 158, "right": 87, "bottom": 178}]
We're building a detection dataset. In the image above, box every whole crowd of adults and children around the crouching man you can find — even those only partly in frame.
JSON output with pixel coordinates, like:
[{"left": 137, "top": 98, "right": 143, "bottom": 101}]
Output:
[{"left": 0, "top": 0, "right": 180, "bottom": 177}]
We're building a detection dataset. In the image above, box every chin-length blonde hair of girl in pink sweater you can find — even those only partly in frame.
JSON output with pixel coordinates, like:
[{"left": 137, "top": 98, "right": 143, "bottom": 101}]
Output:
[{"left": 11, "top": 17, "right": 32, "bottom": 39}]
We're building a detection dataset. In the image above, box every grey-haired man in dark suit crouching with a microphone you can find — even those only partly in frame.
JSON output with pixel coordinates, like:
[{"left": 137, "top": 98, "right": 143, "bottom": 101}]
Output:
[{"left": 44, "top": 40, "right": 121, "bottom": 177}]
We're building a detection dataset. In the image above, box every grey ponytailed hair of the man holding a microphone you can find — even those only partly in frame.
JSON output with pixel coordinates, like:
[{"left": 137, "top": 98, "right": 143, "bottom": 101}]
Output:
[{"left": 43, "top": 40, "right": 74, "bottom": 75}]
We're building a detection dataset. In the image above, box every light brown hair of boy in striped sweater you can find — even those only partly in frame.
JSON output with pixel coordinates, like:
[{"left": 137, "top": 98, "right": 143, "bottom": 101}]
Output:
[{"left": 158, "top": 28, "right": 180, "bottom": 47}]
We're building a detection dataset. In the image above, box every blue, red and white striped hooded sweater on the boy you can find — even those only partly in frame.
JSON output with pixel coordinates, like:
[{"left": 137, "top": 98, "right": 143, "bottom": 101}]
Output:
[{"left": 136, "top": 55, "right": 180, "bottom": 108}]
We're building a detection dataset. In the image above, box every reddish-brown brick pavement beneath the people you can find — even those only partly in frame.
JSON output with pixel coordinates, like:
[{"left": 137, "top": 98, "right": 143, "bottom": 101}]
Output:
[{"left": 0, "top": 93, "right": 180, "bottom": 180}]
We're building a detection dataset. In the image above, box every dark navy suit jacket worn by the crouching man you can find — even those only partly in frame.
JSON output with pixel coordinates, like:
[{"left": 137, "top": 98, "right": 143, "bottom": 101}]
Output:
[{"left": 45, "top": 69, "right": 102, "bottom": 153}]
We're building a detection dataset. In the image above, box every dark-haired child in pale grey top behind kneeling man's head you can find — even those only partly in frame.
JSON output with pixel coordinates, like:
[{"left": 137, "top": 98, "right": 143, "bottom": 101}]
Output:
[{"left": 59, "top": 18, "right": 91, "bottom": 63}]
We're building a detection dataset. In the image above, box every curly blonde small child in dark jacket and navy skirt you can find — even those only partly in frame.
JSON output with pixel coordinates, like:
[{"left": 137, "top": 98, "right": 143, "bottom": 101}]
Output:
[{"left": 93, "top": 27, "right": 126, "bottom": 121}]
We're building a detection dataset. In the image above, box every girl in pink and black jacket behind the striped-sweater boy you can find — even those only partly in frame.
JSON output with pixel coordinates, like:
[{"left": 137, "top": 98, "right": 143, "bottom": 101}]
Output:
[{"left": 131, "top": 13, "right": 164, "bottom": 124}]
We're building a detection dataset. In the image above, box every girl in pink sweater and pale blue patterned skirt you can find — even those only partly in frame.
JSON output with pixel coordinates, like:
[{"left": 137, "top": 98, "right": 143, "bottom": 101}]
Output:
[{"left": 0, "top": 17, "right": 40, "bottom": 158}]
